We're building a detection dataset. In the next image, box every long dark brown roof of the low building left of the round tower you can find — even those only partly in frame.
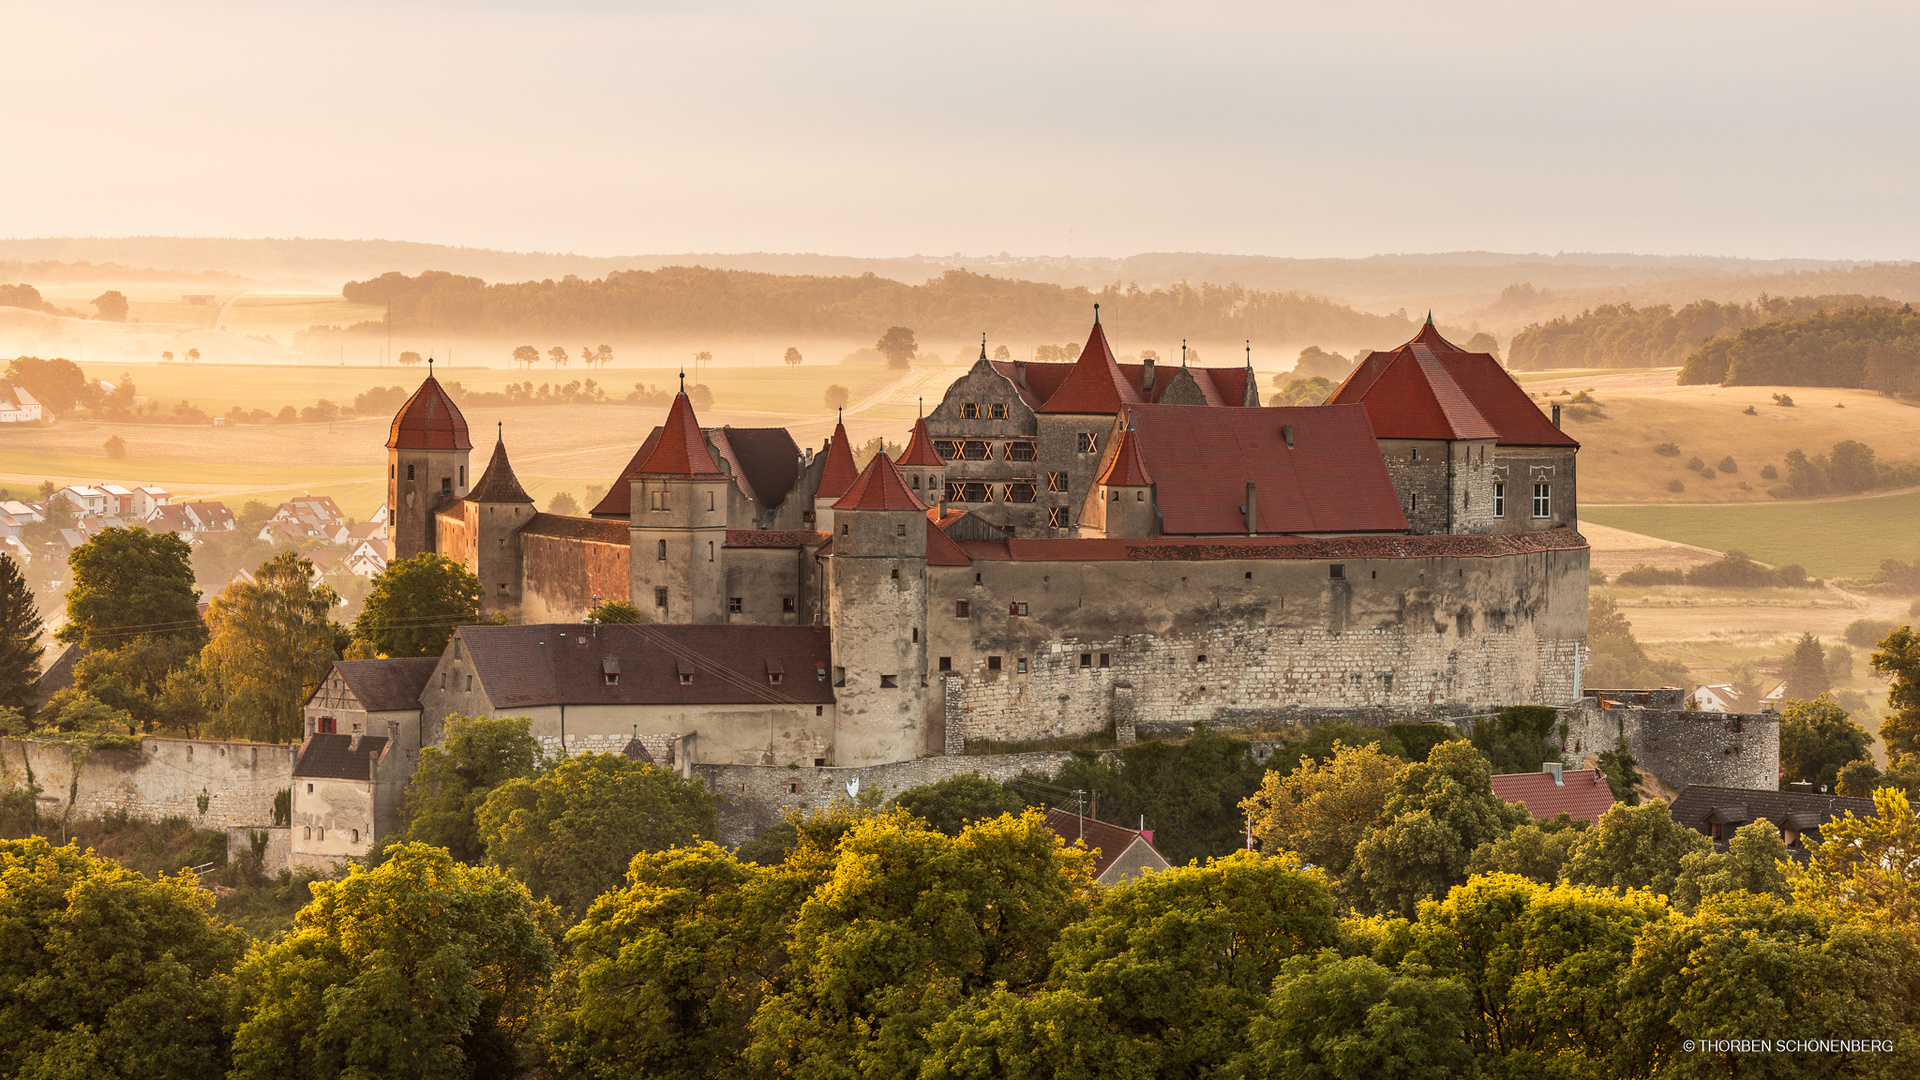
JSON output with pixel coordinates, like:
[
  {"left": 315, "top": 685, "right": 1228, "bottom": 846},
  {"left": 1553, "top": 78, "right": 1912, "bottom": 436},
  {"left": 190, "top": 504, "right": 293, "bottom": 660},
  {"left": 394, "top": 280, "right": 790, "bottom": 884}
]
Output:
[{"left": 457, "top": 623, "right": 833, "bottom": 709}]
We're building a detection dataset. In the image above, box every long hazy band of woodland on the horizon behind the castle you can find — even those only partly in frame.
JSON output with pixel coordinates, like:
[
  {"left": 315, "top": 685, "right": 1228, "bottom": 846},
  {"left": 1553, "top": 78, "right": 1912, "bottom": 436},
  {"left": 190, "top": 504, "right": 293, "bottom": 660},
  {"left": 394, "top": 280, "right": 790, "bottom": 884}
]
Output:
[{"left": 317, "top": 267, "right": 1413, "bottom": 342}]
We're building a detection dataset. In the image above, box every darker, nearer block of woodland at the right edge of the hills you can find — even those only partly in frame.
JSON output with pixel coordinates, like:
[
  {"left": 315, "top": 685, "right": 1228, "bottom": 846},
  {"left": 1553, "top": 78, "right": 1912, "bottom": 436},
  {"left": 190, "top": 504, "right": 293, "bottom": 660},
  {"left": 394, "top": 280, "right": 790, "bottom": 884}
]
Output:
[{"left": 1680, "top": 304, "right": 1920, "bottom": 388}]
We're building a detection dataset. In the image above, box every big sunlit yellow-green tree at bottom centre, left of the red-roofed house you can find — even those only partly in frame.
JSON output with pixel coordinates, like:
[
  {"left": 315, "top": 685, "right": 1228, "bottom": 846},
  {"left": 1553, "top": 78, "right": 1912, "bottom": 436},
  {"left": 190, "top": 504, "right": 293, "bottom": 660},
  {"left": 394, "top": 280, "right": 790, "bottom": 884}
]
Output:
[{"left": 747, "top": 809, "right": 1092, "bottom": 1076}]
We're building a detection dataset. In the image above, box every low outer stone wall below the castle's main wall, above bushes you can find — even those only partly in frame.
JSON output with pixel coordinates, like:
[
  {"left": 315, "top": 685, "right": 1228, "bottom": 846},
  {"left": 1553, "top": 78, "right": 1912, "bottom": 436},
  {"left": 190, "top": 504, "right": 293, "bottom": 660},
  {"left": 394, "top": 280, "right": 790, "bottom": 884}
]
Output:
[{"left": 693, "top": 751, "right": 1073, "bottom": 846}]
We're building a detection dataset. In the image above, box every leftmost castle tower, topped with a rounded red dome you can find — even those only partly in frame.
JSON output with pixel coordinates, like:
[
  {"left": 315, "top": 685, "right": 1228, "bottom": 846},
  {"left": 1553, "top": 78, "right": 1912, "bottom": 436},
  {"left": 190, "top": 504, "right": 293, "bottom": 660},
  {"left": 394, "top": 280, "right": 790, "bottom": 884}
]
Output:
[{"left": 386, "top": 369, "right": 474, "bottom": 563}]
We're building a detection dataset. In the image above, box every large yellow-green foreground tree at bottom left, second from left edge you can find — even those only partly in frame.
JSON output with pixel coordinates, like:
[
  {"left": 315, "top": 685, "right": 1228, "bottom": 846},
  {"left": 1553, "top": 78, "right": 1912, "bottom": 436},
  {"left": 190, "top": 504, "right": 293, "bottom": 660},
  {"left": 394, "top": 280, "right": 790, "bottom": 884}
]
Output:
[{"left": 230, "top": 844, "right": 559, "bottom": 1080}]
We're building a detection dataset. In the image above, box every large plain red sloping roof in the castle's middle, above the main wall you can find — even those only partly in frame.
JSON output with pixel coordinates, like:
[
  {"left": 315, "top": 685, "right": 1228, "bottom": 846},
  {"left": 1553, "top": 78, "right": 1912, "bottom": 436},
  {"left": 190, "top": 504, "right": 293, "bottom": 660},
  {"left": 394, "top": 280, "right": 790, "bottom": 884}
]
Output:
[{"left": 1127, "top": 405, "right": 1407, "bottom": 536}]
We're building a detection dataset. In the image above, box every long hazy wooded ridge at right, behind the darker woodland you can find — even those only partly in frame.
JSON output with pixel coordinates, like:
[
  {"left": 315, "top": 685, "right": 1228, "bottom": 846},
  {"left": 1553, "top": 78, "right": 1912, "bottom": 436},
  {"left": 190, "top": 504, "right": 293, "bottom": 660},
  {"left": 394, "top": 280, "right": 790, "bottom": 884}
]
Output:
[{"left": 1507, "top": 296, "right": 1899, "bottom": 368}]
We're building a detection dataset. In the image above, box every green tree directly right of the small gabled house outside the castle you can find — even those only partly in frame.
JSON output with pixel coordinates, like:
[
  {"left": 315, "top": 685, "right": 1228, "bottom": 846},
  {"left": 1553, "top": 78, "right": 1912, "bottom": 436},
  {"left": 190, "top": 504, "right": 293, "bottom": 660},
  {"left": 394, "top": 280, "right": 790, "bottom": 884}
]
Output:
[{"left": 386, "top": 715, "right": 541, "bottom": 863}]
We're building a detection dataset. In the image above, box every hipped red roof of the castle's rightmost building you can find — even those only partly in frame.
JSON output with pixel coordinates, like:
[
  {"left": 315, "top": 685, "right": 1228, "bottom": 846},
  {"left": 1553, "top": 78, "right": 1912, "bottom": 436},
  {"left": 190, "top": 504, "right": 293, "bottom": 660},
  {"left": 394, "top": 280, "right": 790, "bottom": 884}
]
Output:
[{"left": 1329, "top": 323, "right": 1580, "bottom": 446}]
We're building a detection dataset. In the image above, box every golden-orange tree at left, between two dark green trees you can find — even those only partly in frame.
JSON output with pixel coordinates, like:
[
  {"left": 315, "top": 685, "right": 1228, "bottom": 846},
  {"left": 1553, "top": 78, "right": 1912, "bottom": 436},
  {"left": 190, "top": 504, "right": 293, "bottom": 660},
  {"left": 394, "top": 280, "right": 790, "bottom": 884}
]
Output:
[{"left": 200, "top": 552, "right": 340, "bottom": 742}]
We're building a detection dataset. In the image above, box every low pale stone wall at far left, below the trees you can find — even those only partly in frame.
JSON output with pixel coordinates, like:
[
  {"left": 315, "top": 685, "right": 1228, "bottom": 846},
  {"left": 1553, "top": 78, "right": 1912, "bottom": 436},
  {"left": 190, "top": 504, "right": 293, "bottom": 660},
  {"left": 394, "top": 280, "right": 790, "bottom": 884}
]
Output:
[{"left": 0, "top": 738, "right": 298, "bottom": 828}]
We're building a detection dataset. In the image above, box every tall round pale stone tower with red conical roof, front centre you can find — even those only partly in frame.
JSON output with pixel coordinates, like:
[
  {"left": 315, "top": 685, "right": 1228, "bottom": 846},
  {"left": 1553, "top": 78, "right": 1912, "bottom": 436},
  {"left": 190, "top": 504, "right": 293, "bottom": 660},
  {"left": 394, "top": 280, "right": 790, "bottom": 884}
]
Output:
[{"left": 828, "top": 454, "right": 929, "bottom": 765}]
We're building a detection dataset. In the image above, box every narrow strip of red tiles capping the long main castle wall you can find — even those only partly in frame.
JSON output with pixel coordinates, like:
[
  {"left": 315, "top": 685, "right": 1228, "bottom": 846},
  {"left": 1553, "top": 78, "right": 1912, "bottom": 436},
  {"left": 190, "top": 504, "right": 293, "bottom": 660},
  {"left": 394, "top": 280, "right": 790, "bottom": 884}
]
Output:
[{"left": 958, "top": 528, "right": 1586, "bottom": 563}]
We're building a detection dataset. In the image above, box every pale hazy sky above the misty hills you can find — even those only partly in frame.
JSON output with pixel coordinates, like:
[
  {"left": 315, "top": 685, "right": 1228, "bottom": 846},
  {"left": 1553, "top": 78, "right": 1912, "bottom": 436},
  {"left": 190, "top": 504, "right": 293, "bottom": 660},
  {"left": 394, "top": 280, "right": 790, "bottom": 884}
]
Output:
[{"left": 0, "top": 0, "right": 1920, "bottom": 258}]
